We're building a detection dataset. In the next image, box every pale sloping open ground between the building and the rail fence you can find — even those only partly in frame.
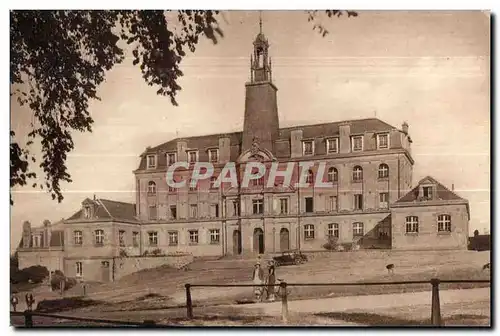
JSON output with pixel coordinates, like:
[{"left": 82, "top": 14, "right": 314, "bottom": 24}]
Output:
[{"left": 59, "top": 251, "right": 490, "bottom": 314}]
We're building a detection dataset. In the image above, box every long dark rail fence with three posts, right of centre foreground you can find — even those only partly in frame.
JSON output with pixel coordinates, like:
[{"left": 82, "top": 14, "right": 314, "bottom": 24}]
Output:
[{"left": 185, "top": 278, "right": 491, "bottom": 327}]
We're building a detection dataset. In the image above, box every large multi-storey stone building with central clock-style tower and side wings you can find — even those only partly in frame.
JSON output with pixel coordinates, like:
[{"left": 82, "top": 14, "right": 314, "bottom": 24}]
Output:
[{"left": 15, "top": 28, "right": 469, "bottom": 280}]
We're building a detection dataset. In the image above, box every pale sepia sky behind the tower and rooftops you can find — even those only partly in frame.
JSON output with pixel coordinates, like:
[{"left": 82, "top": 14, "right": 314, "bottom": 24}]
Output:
[{"left": 11, "top": 11, "right": 490, "bottom": 249}]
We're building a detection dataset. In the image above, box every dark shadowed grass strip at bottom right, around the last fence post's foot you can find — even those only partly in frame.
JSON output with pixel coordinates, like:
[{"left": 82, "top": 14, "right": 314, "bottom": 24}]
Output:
[{"left": 314, "top": 312, "right": 489, "bottom": 327}]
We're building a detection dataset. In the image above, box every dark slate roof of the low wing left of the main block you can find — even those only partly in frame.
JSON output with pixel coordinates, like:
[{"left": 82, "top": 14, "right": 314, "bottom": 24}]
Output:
[{"left": 68, "top": 198, "right": 136, "bottom": 221}]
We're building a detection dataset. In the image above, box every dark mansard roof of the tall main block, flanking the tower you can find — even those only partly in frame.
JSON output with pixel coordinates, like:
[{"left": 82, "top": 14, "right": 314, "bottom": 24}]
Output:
[{"left": 138, "top": 118, "right": 396, "bottom": 170}]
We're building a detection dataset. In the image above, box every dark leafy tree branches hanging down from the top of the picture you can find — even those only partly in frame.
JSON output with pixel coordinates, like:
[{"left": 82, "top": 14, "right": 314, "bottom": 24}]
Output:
[{"left": 10, "top": 10, "right": 357, "bottom": 204}]
